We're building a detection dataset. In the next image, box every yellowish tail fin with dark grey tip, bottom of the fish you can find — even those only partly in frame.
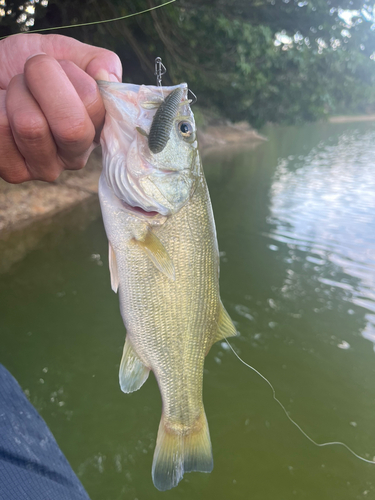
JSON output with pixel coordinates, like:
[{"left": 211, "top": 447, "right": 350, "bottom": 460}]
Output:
[{"left": 152, "top": 411, "right": 214, "bottom": 491}]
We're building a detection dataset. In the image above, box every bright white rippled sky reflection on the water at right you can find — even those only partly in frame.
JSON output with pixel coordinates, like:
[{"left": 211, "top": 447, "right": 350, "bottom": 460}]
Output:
[{"left": 268, "top": 126, "right": 375, "bottom": 348}]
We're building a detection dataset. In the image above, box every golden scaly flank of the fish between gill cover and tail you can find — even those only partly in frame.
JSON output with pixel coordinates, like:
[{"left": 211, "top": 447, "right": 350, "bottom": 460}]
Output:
[{"left": 117, "top": 180, "right": 219, "bottom": 418}]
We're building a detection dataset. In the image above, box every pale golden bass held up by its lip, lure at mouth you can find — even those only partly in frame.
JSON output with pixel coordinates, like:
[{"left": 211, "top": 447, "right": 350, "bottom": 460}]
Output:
[{"left": 98, "top": 82, "right": 236, "bottom": 491}]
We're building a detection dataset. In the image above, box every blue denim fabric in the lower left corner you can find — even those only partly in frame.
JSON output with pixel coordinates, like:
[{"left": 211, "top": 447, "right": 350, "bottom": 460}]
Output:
[{"left": 0, "top": 365, "right": 90, "bottom": 500}]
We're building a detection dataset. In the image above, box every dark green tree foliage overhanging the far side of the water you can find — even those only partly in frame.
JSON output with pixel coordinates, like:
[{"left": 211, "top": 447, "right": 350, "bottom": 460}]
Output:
[{"left": 0, "top": 0, "right": 375, "bottom": 126}]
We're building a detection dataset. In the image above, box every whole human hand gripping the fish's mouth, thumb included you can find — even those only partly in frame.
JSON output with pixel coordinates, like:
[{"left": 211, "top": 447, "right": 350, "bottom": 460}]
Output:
[{"left": 0, "top": 34, "right": 122, "bottom": 184}]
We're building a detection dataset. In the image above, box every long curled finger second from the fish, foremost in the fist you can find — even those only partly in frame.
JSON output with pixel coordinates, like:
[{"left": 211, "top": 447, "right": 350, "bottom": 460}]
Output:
[{"left": 24, "top": 55, "right": 95, "bottom": 169}]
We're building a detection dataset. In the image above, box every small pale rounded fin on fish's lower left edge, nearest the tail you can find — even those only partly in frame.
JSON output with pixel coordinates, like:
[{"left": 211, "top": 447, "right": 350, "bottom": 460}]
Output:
[{"left": 119, "top": 337, "right": 150, "bottom": 393}]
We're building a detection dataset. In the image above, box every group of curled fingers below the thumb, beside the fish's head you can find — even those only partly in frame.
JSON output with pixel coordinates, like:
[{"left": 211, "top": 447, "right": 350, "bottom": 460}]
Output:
[{"left": 0, "top": 55, "right": 101, "bottom": 183}]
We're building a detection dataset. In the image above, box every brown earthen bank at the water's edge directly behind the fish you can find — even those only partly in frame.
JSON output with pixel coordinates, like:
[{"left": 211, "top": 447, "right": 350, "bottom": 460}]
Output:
[{"left": 0, "top": 124, "right": 266, "bottom": 274}]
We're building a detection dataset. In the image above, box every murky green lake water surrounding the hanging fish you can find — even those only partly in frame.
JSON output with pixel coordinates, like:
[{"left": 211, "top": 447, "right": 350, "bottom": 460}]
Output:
[{"left": 0, "top": 123, "right": 375, "bottom": 500}]
